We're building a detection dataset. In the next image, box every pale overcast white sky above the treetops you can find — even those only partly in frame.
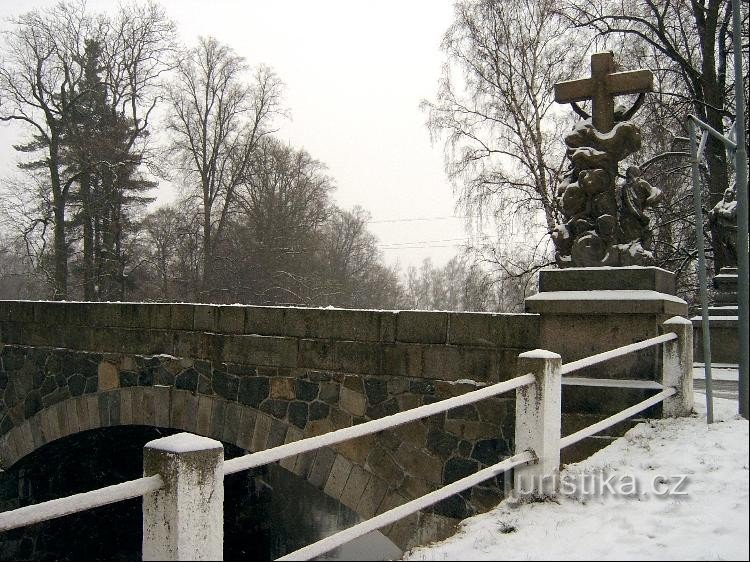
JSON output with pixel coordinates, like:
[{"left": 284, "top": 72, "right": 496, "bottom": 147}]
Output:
[{"left": 0, "top": 0, "right": 484, "bottom": 268}]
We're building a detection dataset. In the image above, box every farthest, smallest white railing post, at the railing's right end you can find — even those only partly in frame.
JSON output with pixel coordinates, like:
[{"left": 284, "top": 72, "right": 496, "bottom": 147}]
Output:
[{"left": 661, "top": 316, "right": 694, "bottom": 418}]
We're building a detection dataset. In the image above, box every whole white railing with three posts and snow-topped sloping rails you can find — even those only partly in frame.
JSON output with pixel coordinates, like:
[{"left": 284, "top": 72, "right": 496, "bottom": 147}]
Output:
[{"left": 0, "top": 317, "right": 693, "bottom": 560}]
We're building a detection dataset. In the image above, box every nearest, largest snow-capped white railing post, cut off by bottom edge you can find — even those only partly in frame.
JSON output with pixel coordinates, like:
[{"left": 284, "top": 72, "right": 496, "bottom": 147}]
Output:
[{"left": 143, "top": 433, "right": 224, "bottom": 560}]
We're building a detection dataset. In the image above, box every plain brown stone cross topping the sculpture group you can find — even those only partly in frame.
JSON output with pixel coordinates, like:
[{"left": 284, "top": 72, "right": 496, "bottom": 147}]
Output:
[{"left": 555, "top": 51, "right": 654, "bottom": 133}]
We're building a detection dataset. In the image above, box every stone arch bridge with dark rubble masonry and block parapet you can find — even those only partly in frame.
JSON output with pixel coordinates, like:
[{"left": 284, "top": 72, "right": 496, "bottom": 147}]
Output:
[{"left": 0, "top": 301, "right": 540, "bottom": 547}]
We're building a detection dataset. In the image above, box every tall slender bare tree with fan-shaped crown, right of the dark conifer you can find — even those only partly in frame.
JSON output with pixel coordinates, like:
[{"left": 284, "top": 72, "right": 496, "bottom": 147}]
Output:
[{"left": 167, "top": 37, "right": 281, "bottom": 298}]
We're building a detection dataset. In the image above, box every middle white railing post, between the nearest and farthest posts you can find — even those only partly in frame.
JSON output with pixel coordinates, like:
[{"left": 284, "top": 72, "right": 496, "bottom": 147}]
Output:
[{"left": 513, "top": 349, "right": 562, "bottom": 496}]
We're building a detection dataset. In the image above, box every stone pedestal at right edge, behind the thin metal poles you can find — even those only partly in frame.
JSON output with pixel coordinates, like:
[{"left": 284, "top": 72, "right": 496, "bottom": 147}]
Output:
[{"left": 690, "top": 267, "right": 740, "bottom": 364}]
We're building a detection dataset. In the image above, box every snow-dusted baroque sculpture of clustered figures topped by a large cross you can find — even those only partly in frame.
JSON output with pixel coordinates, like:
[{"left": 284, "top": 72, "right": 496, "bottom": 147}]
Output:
[{"left": 552, "top": 52, "right": 661, "bottom": 268}]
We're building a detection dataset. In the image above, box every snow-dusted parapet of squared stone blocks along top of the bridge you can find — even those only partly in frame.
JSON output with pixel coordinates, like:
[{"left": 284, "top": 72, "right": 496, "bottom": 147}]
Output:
[{"left": 0, "top": 301, "right": 539, "bottom": 382}]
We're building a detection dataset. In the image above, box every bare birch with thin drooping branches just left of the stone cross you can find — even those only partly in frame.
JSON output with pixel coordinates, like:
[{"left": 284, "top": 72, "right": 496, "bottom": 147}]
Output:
[{"left": 423, "top": 0, "right": 580, "bottom": 235}]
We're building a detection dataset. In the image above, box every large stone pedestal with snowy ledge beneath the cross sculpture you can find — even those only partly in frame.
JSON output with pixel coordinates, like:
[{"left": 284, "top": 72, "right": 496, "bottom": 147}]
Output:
[{"left": 525, "top": 267, "right": 688, "bottom": 462}]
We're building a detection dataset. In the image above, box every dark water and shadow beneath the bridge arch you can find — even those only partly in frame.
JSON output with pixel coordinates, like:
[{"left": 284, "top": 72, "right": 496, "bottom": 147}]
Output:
[{"left": 0, "top": 426, "right": 401, "bottom": 560}]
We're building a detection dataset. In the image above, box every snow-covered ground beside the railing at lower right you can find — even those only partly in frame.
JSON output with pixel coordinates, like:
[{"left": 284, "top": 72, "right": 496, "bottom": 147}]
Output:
[{"left": 404, "top": 394, "right": 750, "bottom": 560}]
